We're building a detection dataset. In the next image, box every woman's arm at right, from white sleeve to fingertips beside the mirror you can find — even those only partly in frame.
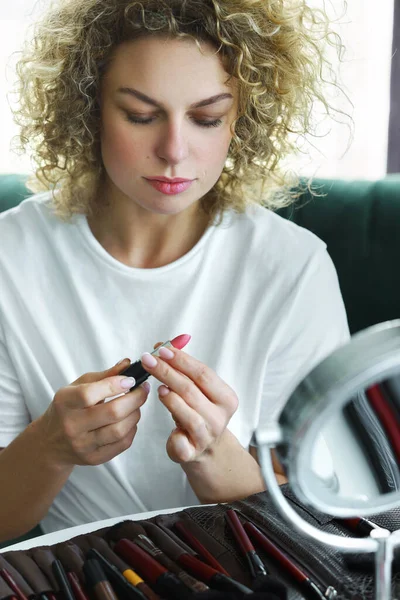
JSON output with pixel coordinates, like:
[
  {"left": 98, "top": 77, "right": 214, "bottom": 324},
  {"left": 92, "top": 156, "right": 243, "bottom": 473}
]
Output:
[{"left": 142, "top": 249, "right": 348, "bottom": 503}]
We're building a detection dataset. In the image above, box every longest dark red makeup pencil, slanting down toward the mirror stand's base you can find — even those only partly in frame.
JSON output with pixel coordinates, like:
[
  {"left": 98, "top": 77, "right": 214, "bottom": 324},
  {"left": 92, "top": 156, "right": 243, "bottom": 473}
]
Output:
[{"left": 243, "top": 521, "right": 332, "bottom": 600}]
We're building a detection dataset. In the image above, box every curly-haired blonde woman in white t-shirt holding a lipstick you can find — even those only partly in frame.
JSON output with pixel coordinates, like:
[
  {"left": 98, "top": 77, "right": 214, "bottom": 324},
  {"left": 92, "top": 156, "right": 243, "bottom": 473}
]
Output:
[{"left": 0, "top": 0, "right": 348, "bottom": 539}]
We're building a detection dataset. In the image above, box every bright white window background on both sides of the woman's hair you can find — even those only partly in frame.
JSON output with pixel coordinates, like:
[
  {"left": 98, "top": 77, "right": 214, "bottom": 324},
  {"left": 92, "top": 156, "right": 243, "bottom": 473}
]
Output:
[{"left": 0, "top": 0, "right": 394, "bottom": 179}]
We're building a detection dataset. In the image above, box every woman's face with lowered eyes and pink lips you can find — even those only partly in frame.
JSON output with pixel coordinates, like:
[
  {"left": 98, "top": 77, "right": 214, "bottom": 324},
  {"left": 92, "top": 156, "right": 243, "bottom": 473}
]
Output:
[{"left": 101, "top": 38, "right": 237, "bottom": 215}]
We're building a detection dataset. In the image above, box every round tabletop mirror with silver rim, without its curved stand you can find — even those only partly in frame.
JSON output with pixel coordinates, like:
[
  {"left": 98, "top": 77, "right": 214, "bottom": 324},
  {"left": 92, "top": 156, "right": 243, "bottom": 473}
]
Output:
[{"left": 276, "top": 320, "right": 400, "bottom": 517}]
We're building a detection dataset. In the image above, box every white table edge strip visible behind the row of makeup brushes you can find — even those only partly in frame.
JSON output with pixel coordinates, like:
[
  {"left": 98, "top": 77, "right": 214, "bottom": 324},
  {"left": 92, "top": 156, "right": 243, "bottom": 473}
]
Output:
[{"left": 1, "top": 506, "right": 197, "bottom": 552}]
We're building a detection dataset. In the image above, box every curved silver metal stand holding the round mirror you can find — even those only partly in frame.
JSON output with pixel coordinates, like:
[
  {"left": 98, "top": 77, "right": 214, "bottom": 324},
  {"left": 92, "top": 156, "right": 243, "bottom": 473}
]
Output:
[{"left": 256, "top": 431, "right": 400, "bottom": 600}]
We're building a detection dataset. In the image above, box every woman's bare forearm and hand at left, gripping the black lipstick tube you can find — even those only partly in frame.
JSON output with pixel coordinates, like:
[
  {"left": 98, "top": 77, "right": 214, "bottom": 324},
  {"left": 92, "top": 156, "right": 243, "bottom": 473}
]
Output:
[{"left": 0, "top": 360, "right": 147, "bottom": 541}]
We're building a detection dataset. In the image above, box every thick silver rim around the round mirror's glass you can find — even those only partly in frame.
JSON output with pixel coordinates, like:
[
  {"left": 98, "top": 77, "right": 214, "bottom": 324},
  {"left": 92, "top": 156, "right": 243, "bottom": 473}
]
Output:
[{"left": 272, "top": 319, "right": 400, "bottom": 517}]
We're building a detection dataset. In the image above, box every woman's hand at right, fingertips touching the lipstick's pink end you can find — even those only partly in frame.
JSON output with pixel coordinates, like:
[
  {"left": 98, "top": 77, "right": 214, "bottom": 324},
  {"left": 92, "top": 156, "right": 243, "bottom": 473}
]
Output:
[{"left": 142, "top": 344, "right": 239, "bottom": 463}]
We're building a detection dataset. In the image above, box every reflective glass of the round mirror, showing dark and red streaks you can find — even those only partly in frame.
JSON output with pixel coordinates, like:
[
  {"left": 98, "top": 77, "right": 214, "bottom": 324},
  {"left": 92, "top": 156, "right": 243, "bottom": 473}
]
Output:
[{"left": 304, "top": 384, "right": 400, "bottom": 505}]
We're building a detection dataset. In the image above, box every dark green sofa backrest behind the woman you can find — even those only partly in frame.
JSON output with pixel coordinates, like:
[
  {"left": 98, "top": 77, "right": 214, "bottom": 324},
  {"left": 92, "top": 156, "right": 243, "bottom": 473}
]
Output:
[{"left": 0, "top": 174, "right": 400, "bottom": 547}]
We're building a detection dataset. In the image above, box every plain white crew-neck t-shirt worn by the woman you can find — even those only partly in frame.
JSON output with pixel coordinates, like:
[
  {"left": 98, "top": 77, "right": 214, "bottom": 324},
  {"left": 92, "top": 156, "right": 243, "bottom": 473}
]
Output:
[{"left": 0, "top": 193, "right": 349, "bottom": 532}]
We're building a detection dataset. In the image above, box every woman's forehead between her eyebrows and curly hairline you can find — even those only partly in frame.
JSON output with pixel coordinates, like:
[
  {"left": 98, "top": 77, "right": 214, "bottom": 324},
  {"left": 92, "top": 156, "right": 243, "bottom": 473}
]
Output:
[{"left": 103, "top": 36, "right": 235, "bottom": 100}]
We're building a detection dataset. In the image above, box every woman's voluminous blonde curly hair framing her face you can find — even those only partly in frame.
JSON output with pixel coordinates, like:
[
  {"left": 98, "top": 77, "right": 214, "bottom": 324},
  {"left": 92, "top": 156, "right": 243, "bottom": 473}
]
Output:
[{"left": 13, "top": 0, "right": 342, "bottom": 223}]
